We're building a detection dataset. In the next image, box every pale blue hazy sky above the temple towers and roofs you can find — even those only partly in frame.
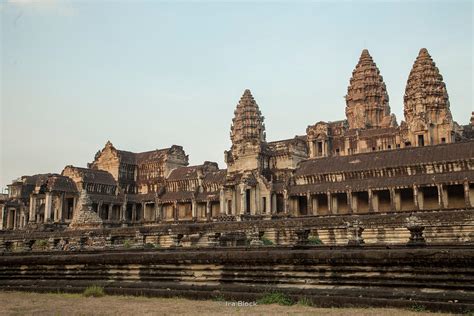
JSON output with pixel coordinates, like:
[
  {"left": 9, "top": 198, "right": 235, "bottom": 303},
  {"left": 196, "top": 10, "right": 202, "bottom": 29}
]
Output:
[{"left": 0, "top": 0, "right": 474, "bottom": 188}]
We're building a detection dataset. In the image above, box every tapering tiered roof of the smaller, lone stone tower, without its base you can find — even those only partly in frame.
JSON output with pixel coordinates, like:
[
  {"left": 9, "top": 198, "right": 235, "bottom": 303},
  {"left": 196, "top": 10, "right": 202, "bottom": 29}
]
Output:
[{"left": 230, "top": 89, "right": 265, "bottom": 144}]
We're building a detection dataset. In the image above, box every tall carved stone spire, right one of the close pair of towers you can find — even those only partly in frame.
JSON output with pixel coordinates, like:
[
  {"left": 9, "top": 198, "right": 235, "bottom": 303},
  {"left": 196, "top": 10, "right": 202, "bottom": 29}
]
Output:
[{"left": 404, "top": 48, "right": 454, "bottom": 146}]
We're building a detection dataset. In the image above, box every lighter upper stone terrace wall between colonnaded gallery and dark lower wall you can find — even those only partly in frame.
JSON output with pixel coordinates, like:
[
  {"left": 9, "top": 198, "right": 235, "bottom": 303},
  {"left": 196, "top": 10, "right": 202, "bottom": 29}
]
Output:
[{"left": 0, "top": 209, "right": 474, "bottom": 251}]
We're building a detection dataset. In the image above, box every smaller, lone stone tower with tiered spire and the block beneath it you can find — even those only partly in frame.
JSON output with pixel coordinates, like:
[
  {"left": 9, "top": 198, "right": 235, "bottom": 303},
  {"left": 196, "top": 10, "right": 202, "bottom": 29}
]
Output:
[{"left": 225, "top": 89, "right": 265, "bottom": 173}]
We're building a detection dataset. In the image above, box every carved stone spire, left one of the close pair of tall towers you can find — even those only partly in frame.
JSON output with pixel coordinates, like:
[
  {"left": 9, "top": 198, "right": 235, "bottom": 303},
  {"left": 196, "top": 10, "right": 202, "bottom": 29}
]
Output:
[{"left": 346, "top": 49, "right": 396, "bottom": 129}]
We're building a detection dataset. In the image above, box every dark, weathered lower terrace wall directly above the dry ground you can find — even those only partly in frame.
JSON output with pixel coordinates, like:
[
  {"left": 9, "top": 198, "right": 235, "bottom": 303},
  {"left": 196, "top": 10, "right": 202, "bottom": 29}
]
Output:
[{"left": 0, "top": 245, "right": 474, "bottom": 312}]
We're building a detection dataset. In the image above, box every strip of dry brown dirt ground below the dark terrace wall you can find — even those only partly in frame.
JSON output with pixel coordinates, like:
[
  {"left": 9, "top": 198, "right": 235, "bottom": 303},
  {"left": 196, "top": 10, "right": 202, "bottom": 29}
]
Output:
[{"left": 0, "top": 292, "right": 450, "bottom": 316}]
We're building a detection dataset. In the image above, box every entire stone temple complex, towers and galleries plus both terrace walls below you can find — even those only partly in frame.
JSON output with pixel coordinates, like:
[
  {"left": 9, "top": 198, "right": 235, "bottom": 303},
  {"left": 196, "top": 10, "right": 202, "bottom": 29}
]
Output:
[{"left": 0, "top": 48, "right": 474, "bottom": 312}]
